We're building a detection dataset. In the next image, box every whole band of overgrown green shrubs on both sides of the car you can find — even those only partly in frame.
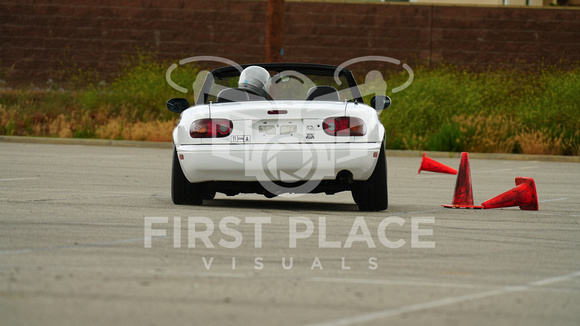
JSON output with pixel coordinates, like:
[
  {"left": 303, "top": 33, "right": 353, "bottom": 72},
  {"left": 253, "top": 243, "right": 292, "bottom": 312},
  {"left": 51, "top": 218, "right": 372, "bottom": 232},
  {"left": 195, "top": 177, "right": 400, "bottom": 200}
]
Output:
[{"left": 0, "top": 53, "right": 580, "bottom": 155}]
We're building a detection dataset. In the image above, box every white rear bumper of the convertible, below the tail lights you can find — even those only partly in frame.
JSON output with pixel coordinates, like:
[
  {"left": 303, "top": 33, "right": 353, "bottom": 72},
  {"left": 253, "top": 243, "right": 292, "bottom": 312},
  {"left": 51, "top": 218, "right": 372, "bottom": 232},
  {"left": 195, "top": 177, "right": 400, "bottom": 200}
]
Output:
[{"left": 176, "top": 143, "right": 381, "bottom": 183}]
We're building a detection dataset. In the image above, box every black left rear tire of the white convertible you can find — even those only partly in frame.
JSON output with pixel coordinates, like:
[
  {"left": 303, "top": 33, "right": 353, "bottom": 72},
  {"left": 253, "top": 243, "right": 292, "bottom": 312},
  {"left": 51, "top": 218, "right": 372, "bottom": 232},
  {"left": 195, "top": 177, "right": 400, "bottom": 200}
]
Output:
[{"left": 171, "top": 148, "right": 204, "bottom": 205}]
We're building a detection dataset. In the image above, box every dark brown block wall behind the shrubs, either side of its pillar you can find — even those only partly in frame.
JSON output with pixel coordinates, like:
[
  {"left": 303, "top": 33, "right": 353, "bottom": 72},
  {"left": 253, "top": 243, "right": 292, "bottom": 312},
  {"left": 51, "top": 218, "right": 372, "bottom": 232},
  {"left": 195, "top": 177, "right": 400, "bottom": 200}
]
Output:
[{"left": 0, "top": 0, "right": 580, "bottom": 84}]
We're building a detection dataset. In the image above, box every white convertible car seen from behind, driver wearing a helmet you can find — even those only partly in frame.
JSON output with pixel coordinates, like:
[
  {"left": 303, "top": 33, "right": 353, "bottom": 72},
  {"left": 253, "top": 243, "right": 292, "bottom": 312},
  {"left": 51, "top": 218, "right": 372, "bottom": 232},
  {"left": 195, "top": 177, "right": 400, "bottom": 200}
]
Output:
[{"left": 167, "top": 63, "right": 391, "bottom": 211}]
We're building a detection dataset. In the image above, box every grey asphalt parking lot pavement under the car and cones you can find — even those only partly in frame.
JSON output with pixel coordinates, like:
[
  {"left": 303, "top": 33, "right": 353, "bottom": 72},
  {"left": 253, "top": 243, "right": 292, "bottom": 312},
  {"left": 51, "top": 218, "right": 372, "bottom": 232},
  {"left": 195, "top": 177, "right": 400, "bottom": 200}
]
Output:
[{"left": 0, "top": 141, "right": 580, "bottom": 326}]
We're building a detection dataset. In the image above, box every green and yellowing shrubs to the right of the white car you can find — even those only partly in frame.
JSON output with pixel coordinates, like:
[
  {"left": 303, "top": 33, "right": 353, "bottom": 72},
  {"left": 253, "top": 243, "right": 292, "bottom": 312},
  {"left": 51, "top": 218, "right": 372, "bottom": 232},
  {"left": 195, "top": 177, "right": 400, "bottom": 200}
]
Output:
[{"left": 381, "top": 65, "right": 580, "bottom": 155}]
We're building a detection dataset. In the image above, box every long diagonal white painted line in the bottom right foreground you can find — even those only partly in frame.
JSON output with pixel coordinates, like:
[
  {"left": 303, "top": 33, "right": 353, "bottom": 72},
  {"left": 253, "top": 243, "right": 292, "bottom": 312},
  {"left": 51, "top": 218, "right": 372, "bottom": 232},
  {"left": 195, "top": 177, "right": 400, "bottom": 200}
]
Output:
[{"left": 307, "top": 271, "right": 580, "bottom": 326}]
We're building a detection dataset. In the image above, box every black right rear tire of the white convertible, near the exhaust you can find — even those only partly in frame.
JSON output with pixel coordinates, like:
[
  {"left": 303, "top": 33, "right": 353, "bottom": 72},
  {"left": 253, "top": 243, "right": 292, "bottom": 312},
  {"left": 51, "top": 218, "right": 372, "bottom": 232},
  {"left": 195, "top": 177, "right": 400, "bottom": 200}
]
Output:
[{"left": 352, "top": 144, "right": 389, "bottom": 212}]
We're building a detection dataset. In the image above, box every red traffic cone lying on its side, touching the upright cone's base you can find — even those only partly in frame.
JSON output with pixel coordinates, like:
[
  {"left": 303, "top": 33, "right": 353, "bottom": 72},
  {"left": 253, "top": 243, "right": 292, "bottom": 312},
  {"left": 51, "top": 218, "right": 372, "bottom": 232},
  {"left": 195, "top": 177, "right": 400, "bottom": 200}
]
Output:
[{"left": 481, "top": 177, "right": 538, "bottom": 211}]
